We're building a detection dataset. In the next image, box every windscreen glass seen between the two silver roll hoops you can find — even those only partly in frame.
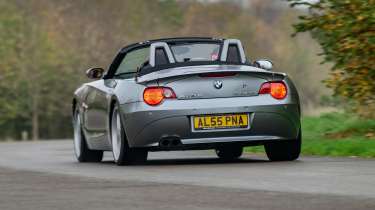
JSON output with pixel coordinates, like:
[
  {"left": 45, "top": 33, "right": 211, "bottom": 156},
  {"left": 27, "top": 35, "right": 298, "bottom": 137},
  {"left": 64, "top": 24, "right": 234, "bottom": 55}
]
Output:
[{"left": 170, "top": 43, "right": 220, "bottom": 62}]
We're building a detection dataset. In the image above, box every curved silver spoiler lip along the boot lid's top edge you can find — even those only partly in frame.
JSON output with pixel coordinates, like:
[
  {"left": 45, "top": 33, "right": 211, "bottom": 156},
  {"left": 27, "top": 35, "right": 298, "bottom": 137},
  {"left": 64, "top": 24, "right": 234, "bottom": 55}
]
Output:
[{"left": 136, "top": 65, "right": 286, "bottom": 83}]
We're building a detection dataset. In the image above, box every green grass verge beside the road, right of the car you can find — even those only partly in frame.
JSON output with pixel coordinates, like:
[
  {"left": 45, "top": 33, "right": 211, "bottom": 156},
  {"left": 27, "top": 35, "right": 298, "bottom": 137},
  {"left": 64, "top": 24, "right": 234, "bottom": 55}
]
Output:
[{"left": 245, "top": 113, "right": 375, "bottom": 157}]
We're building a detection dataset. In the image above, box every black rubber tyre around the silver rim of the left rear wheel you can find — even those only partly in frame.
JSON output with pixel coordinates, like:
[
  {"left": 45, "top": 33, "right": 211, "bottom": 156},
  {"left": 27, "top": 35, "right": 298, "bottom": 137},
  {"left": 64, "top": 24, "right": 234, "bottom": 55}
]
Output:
[{"left": 111, "top": 105, "right": 148, "bottom": 166}]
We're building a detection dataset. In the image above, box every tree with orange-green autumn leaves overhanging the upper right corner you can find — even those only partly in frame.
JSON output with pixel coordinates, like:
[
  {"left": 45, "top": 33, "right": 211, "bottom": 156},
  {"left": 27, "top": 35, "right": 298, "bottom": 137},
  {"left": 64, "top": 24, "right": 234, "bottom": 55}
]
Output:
[{"left": 289, "top": 0, "right": 375, "bottom": 117}]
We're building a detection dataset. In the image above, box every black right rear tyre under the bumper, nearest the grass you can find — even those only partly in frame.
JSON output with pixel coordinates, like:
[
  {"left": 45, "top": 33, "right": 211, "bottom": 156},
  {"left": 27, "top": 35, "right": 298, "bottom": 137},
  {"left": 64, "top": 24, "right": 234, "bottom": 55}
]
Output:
[{"left": 264, "top": 130, "right": 302, "bottom": 161}]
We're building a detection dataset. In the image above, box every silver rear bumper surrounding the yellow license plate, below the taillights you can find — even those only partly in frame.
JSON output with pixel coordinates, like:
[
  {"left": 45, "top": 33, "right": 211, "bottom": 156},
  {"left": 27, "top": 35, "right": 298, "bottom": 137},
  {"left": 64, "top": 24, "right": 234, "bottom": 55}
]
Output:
[{"left": 120, "top": 95, "right": 300, "bottom": 150}]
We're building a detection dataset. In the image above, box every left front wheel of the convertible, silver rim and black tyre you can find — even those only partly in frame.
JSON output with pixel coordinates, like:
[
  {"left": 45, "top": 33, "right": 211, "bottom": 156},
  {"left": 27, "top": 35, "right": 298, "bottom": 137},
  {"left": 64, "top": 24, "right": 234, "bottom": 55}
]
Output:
[{"left": 73, "top": 109, "right": 103, "bottom": 162}]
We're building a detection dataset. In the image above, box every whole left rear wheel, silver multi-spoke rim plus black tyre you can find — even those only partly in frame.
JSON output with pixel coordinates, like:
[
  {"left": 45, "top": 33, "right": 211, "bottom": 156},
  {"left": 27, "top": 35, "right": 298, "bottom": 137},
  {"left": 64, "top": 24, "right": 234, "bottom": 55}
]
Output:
[{"left": 111, "top": 105, "right": 148, "bottom": 165}]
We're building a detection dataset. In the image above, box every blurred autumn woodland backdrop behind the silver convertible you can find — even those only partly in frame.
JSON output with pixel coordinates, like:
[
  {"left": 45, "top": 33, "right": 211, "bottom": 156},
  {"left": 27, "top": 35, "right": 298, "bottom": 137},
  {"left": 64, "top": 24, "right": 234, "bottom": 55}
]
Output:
[{"left": 0, "top": 0, "right": 375, "bottom": 156}]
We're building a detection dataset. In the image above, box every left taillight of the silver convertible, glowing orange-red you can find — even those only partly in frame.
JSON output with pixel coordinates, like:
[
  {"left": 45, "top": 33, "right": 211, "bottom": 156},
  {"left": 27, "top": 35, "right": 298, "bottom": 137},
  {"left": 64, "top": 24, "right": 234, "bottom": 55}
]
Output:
[{"left": 143, "top": 87, "right": 176, "bottom": 106}]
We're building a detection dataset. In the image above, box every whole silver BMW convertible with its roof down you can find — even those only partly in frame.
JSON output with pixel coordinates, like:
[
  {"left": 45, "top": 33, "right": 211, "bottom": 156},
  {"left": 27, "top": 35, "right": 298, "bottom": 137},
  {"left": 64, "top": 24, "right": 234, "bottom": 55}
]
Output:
[{"left": 72, "top": 37, "right": 301, "bottom": 165}]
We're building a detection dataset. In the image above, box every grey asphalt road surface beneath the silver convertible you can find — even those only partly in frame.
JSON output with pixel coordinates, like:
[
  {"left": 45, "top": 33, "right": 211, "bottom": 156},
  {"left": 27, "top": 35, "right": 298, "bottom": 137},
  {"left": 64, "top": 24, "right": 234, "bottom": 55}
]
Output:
[{"left": 0, "top": 141, "right": 375, "bottom": 210}]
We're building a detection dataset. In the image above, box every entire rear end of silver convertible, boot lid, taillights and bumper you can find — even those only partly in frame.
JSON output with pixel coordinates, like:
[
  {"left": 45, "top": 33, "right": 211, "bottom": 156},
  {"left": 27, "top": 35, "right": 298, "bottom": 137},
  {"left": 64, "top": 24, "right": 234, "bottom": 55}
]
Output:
[{"left": 120, "top": 65, "right": 300, "bottom": 150}]
